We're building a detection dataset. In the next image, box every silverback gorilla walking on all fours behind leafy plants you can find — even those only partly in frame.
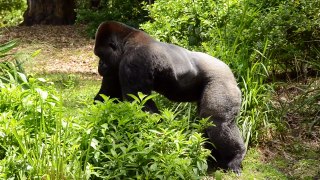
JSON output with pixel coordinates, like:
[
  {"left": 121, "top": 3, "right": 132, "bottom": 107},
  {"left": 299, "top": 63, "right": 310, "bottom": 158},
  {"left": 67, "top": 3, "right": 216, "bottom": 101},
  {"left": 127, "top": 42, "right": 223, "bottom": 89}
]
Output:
[{"left": 94, "top": 21, "right": 246, "bottom": 173}]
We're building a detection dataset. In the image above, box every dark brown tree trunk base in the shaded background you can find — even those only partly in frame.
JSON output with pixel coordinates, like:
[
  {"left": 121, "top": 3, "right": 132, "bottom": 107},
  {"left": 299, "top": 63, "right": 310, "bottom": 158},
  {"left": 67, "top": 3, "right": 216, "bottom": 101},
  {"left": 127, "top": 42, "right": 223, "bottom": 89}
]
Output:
[{"left": 22, "top": 0, "right": 76, "bottom": 26}]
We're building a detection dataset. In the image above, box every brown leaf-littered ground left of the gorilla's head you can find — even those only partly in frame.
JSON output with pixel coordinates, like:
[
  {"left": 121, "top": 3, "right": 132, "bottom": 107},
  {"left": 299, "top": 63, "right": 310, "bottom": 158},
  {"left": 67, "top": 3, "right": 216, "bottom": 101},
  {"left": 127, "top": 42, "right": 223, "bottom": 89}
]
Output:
[{"left": 0, "top": 25, "right": 99, "bottom": 78}]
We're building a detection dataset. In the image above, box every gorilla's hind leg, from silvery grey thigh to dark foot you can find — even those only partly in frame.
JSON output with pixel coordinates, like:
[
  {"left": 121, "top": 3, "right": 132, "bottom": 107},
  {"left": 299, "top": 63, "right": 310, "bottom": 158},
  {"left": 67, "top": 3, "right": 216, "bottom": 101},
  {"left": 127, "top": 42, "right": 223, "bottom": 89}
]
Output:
[{"left": 199, "top": 81, "right": 246, "bottom": 174}]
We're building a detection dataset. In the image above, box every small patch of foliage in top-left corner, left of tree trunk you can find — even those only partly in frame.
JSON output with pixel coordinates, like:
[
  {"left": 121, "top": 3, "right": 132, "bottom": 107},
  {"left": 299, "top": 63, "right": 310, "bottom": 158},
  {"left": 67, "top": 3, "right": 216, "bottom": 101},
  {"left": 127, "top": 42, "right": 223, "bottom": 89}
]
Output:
[{"left": 0, "top": 0, "right": 27, "bottom": 27}]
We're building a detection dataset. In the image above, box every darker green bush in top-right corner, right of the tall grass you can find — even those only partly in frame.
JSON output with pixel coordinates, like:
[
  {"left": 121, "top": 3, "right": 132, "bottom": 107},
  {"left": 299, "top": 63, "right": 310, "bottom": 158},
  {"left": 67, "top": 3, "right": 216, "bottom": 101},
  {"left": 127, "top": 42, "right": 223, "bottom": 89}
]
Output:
[{"left": 254, "top": 0, "right": 320, "bottom": 73}]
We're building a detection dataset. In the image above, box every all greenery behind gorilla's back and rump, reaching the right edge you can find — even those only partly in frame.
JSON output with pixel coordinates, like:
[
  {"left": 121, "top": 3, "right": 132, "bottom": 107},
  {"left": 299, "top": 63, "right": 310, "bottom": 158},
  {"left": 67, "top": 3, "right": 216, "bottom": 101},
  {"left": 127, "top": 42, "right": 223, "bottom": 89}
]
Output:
[{"left": 141, "top": 0, "right": 320, "bottom": 144}]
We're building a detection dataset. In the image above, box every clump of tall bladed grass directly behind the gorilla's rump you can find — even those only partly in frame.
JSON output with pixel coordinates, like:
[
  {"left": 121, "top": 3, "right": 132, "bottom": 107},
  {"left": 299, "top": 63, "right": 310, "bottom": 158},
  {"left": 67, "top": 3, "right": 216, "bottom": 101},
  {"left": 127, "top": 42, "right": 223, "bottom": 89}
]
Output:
[{"left": 205, "top": 38, "right": 278, "bottom": 145}]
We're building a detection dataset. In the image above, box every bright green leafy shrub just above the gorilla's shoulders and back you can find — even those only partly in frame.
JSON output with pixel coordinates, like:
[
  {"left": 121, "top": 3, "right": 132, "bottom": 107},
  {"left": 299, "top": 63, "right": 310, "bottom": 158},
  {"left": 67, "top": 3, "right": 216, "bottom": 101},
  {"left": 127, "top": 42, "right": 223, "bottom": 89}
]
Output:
[{"left": 141, "top": 0, "right": 218, "bottom": 47}]
